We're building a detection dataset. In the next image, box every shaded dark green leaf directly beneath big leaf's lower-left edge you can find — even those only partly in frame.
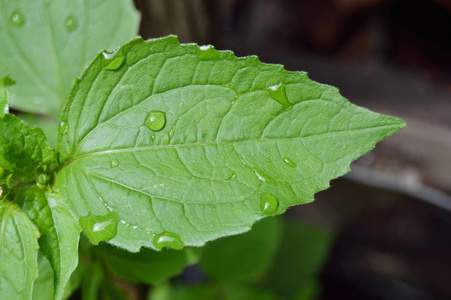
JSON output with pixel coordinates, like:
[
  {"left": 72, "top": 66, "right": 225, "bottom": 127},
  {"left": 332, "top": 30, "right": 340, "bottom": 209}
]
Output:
[{"left": 102, "top": 245, "right": 196, "bottom": 284}]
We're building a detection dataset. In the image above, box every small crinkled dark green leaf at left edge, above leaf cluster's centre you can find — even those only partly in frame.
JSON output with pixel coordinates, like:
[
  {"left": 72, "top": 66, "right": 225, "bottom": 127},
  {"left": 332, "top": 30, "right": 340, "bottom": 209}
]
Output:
[{"left": 0, "top": 114, "right": 55, "bottom": 182}]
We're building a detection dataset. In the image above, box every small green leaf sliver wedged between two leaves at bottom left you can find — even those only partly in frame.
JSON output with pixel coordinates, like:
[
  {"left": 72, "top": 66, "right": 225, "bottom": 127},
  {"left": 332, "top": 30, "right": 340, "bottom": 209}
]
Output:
[{"left": 33, "top": 255, "right": 54, "bottom": 300}]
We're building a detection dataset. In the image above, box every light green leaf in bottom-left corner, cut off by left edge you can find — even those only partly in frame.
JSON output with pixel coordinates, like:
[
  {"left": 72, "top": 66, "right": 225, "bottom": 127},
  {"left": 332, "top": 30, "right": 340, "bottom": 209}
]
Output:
[{"left": 0, "top": 199, "right": 39, "bottom": 300}]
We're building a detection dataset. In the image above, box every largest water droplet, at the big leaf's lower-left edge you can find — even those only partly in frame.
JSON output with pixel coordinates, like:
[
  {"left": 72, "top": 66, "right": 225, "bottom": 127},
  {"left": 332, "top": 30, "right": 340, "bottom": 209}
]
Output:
[{"left": 79, "top": 213, "right": 119, "bottom": 244}]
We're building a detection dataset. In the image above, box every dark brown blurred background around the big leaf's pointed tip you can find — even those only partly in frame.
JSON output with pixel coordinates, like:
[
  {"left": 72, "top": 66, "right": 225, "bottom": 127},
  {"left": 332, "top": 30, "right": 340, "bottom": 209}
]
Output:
[{"left": 135, "top": 0, "right": 451, "bottom": 299}]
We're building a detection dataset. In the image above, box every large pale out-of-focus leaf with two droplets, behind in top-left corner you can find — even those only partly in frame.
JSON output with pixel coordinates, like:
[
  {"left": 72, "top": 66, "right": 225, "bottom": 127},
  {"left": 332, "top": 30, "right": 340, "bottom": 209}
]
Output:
[{"left": 0, "top": 0, "right": 140, "bottom": 117}]
